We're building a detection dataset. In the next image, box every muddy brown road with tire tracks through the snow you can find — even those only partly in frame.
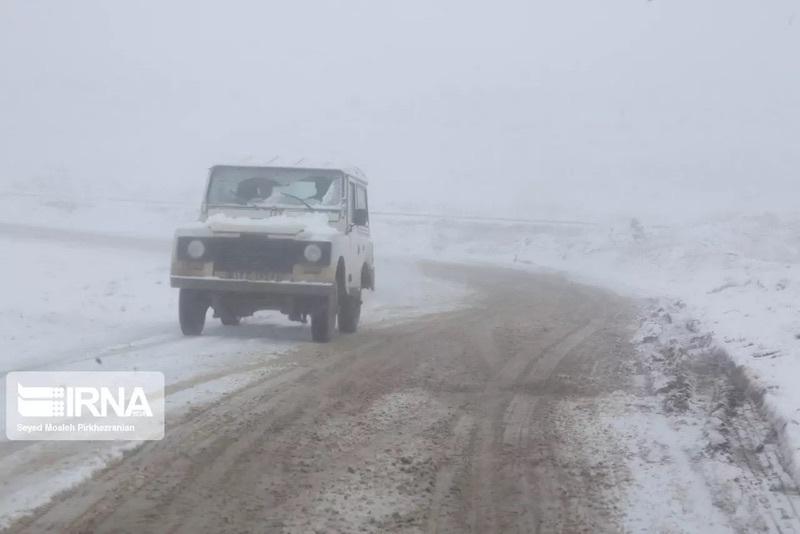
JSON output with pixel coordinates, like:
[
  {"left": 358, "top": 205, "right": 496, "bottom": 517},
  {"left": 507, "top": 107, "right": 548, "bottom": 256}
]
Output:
[{"left": 10, "top": 266, "right": 797, "bottom": 533}]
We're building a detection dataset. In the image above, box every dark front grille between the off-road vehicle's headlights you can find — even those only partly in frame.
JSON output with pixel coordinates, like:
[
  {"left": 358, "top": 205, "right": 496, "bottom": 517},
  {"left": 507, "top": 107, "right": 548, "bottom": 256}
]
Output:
[{"left": 214, "top": 236, "right": 302, "bottom": 273}]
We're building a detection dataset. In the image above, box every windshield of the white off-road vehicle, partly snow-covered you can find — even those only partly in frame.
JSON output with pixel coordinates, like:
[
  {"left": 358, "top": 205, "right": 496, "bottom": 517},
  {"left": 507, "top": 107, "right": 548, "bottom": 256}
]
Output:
[{"left": 207, "top": 167, "right": 342, "bottom": 209}]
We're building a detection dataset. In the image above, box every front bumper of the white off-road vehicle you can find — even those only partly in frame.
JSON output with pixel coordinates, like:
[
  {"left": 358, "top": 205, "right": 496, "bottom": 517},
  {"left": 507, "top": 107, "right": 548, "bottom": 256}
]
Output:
[{"left": 170, "top": 275, "right": 335, "bottom": 297}]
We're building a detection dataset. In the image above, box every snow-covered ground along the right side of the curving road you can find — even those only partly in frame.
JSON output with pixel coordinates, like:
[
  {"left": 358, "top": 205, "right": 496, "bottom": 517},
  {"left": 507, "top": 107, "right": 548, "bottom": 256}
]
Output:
[{"left": 381, "top": 213, "right": 800, "bottom": 483}]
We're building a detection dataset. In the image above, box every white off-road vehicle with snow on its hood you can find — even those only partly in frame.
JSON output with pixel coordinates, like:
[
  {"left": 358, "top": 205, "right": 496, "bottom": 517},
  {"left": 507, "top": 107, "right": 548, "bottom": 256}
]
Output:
[{"left": 170, "top": 165, "right": 375, "bottom": 341}]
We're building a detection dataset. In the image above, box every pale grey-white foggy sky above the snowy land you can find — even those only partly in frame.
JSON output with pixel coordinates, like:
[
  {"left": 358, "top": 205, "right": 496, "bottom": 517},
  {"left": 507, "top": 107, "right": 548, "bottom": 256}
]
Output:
[{"left": 0, "top": 0, "right": 800, "bottom": 220}]
